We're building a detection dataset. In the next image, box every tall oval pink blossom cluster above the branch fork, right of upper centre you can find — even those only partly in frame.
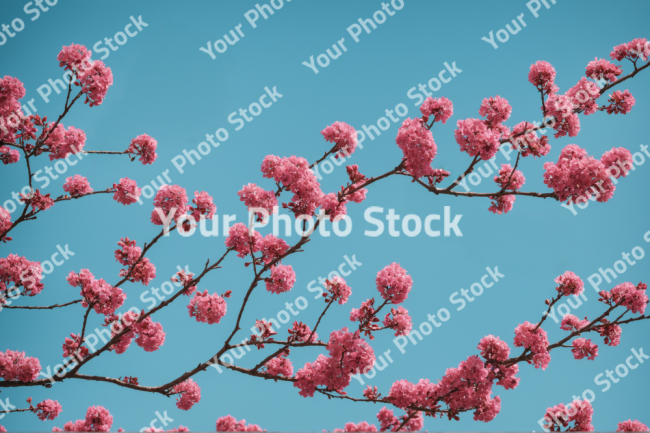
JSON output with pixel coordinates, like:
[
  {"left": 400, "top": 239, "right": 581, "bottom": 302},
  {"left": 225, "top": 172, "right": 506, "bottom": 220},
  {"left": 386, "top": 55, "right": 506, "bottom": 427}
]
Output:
[{"left": 395, "top": 118, "right": 438, "bottom": 178}]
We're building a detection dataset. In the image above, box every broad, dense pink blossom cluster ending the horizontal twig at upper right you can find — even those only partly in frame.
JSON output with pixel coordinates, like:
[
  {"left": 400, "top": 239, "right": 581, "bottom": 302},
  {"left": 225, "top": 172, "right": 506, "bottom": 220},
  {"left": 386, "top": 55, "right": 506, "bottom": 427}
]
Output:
[{"left": 544, "top": 144, "right": 616, "bottom": 203}]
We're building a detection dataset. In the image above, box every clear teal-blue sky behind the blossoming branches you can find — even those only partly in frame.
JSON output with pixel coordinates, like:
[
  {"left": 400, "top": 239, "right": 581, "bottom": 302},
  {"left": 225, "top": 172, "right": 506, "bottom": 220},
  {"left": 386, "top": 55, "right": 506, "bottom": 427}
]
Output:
[{"left": 0, "top": 0, "right": 650, "bottom": 431}]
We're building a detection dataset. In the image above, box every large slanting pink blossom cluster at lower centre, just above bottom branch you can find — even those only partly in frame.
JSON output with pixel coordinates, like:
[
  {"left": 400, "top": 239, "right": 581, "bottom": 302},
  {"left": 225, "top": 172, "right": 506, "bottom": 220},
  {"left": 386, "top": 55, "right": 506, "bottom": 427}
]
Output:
[{"left": 293, "top": 328, "right": 375, "bottom": 397}]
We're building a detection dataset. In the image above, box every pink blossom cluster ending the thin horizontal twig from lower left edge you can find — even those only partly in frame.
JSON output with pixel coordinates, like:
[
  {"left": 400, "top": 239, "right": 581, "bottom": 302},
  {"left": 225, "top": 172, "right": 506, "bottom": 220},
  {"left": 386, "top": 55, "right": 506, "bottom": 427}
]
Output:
[{"left": 66, "top": 269, "right": 126, "bottom": 316}]
